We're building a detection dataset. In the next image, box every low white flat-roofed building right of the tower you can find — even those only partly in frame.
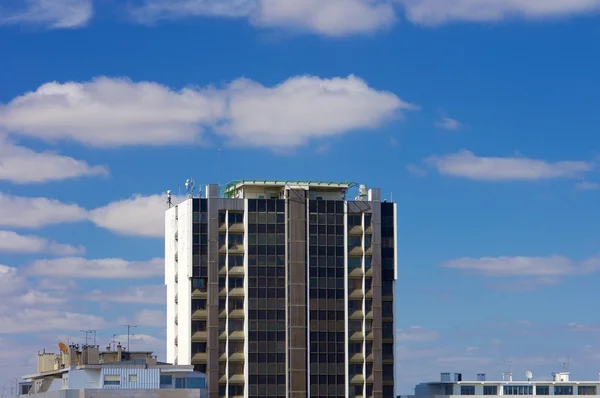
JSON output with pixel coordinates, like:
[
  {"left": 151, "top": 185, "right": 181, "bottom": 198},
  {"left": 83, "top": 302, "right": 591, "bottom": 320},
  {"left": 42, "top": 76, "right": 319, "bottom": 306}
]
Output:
[{"left": 398, "top": 372, "right": 600, "bottom": 398}]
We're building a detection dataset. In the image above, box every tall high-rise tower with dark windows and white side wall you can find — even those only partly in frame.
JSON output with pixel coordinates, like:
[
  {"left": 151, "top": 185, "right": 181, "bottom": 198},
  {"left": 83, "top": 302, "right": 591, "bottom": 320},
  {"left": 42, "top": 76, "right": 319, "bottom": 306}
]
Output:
[{"left": 165, "top": 180, "right": 397, "bottom": 398}]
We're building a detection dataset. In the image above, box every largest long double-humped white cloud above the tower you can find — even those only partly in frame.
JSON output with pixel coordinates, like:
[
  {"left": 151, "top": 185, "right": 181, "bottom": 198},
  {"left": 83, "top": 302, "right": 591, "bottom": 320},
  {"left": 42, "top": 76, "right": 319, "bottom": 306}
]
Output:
[{"left": 0, "top": 75, "right": 417, "bottom": 149}]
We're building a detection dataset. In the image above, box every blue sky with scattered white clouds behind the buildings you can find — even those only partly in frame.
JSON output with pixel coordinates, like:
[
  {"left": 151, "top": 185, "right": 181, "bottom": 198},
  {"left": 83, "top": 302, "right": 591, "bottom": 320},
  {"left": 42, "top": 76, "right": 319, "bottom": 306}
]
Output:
[{"left": 0, "top": 0, "right": 600, "bottom": 393}]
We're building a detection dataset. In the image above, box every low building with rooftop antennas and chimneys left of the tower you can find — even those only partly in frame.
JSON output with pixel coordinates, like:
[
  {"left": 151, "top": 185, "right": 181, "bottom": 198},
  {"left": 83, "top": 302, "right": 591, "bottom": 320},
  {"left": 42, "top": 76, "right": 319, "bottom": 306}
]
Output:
[{"left": 13, "top": 344, "right": 206, "bottom": 398}]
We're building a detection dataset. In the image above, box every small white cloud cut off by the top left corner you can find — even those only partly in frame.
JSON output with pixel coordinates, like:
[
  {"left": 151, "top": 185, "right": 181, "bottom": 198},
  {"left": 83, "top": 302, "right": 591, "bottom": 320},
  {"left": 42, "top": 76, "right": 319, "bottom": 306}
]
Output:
[{"left": 0, "top": 0, "right": 93, "bottom": 29}]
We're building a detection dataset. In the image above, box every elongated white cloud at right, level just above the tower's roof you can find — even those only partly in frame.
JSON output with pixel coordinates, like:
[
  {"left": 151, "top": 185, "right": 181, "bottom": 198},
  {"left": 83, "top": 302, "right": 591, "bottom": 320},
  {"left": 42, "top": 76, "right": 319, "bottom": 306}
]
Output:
[{"left": 425, "top": 149, "right": 595, "bottom": 181}]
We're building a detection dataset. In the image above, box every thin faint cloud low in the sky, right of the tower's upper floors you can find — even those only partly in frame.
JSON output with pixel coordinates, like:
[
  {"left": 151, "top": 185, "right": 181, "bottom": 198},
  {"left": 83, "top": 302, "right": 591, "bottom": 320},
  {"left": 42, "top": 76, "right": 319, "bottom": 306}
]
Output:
[{"left": 441, "top": 256, "right": 600, "bottom": 277}]
